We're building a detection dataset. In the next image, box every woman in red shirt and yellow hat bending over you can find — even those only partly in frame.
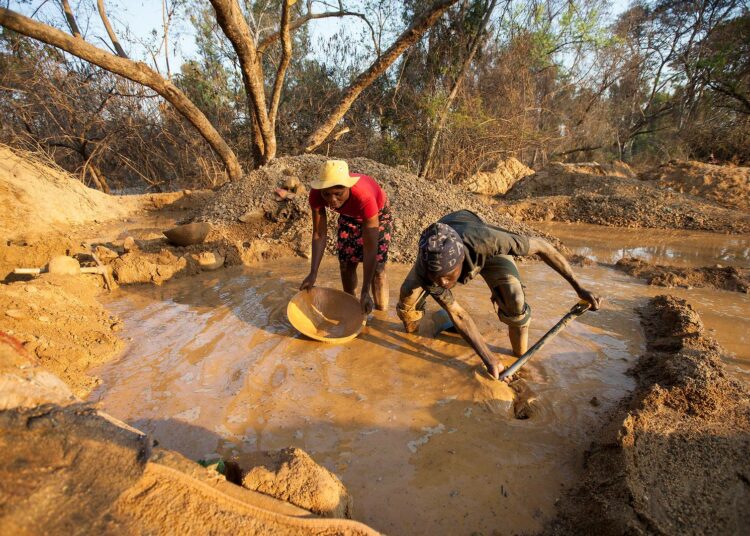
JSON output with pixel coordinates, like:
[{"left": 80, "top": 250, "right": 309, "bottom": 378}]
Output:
[{"left": 300, "top": 160, "right": 393, "bottom": 314}]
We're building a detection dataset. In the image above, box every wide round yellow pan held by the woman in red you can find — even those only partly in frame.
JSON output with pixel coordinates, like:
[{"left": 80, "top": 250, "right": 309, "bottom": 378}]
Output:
[{"left": 286, "top": 287, "right": 366, "bottom": 344}]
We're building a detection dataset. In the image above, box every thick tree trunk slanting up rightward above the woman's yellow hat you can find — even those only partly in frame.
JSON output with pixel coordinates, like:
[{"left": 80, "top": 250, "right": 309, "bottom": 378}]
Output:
[{"left": 304, "top": 0, "right": 458, "bottom": 152}]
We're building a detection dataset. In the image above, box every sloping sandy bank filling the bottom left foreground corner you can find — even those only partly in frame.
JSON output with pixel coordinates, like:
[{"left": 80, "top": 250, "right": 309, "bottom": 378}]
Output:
[{"left": 0, "top": 342, "right": 376, "bottom": 535}]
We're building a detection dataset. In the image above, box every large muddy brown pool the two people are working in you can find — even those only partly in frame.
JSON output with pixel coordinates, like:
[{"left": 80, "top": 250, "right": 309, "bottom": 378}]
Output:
[{"left": 91, "top": 225, "right": 750, "bottom": 534}]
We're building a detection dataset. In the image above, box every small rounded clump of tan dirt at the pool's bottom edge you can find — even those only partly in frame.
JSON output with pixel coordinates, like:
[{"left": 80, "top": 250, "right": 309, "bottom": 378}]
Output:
[{"left": 242, "top": 448, "right": 352, "bottom": 518}]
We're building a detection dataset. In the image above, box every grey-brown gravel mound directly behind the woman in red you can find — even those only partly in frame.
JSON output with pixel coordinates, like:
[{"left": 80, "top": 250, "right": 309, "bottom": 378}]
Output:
[{"left": 196, "top": 155, "right": 552, "bottom": 262}]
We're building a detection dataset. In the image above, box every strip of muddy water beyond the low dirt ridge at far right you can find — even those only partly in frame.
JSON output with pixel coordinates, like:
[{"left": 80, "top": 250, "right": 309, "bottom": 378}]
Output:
[{"left": 533, "top": 222, "right": 750, "bottom": 268}]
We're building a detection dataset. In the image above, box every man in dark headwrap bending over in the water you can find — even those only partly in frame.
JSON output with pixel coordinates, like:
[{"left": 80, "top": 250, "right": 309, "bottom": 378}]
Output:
[{"left": 396, "top": 210, "right": 601, "bottom": 379}]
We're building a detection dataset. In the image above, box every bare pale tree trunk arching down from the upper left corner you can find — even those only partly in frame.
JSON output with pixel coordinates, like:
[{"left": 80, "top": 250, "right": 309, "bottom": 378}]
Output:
[{"left": 0, "top": 8, "right": 242, "bottom": 180}]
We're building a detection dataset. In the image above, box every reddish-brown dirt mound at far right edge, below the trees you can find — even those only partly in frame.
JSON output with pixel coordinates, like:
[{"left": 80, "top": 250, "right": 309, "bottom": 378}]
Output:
[{"left": 639, "top": 160, "right": 750, "bottom": 212}]
